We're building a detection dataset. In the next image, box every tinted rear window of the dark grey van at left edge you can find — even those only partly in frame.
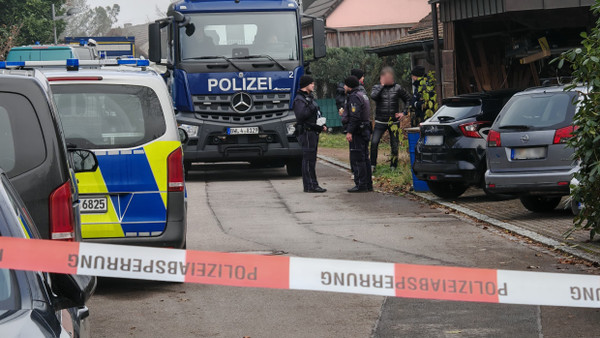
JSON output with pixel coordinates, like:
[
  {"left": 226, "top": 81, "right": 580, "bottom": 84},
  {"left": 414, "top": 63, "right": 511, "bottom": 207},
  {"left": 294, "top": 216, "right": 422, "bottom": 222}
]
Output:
[{"left": 0, "top": 93, "right": 46, "bottom": 177}]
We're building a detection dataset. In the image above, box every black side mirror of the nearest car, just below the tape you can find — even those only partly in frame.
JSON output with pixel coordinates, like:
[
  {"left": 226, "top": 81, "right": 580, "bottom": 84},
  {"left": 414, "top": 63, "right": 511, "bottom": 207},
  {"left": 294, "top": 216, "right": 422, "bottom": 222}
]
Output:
[{"left": 50, "top": 273, "right": 98, "bottom": 310}]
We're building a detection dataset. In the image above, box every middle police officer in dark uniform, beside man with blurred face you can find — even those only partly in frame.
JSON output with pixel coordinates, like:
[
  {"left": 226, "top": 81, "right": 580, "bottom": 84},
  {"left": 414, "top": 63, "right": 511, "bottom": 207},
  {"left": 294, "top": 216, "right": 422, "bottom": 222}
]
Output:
[{"left": 342, "top": 76, "right": 373, "bottom": 193}]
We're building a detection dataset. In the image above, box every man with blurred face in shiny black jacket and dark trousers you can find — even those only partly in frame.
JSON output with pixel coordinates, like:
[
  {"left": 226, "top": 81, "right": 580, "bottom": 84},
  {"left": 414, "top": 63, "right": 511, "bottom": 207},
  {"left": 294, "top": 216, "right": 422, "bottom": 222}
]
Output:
[{"left": 371, "top": 67, "right": 410, "bottom": 170}]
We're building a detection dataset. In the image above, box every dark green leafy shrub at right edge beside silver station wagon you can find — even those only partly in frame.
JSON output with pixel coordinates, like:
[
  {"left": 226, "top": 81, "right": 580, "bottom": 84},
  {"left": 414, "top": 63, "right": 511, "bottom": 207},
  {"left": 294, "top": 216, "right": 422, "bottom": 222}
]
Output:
[{"left": 553, "top": 0, "right": 600, "bottom": 239}]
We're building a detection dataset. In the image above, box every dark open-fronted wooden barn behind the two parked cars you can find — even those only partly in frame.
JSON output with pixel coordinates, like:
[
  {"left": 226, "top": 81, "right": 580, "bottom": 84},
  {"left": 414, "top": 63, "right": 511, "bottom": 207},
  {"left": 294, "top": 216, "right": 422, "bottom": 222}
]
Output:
[{"left": 373, "top": 0, "right": 596, "bottom": 97}]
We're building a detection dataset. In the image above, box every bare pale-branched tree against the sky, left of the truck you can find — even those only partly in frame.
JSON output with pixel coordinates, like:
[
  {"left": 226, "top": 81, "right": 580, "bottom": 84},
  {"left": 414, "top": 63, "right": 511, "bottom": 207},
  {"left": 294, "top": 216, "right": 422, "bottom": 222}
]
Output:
[{"left": 64, "top": 0, "right": 121, "bottom": 36}]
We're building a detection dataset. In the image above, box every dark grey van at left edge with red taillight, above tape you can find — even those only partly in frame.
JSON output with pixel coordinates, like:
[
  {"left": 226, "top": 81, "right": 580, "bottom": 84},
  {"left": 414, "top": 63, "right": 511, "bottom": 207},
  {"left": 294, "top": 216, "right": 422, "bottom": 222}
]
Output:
[{"left": 0, "top": 70, "right": 97, "bottom": 240}]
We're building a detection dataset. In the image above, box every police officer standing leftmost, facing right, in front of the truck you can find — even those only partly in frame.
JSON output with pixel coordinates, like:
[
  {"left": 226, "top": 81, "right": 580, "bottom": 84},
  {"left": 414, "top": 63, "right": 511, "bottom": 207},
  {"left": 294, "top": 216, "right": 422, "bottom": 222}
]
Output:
[{"left": 294, "top": 75, "right": 327, "bottom": 193}]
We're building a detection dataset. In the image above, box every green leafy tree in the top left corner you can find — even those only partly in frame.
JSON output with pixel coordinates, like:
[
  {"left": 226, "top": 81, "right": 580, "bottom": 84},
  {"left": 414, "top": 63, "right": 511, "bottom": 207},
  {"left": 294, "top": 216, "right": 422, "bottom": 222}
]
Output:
[{"left": 0, "top": 0, "right": 64, "bottom": 57}]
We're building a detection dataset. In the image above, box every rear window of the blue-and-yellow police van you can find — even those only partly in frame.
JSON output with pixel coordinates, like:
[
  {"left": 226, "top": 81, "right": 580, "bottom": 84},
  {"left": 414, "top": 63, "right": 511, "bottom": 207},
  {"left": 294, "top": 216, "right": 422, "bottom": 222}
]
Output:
[{"left": 52, "top": 84, "right": 166, "bottom": 149}]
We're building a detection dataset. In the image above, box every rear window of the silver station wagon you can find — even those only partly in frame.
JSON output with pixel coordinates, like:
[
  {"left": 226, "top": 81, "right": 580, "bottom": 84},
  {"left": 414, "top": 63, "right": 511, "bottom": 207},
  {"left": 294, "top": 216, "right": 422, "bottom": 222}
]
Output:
[{"left": 495, "top": 92, "right": 576, "bottom": 129}]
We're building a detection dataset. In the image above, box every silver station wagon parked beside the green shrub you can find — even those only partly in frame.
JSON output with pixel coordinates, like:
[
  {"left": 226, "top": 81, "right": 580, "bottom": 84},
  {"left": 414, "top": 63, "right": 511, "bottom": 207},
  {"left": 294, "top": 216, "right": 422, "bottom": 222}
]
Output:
[{"left": 485, "top": 86, "right": 584, "bottom": 212}]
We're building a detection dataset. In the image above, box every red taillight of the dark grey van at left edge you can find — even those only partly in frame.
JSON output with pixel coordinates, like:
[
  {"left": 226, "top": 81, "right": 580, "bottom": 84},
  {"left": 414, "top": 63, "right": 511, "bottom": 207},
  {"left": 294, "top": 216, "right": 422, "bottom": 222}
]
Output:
[{"left": 49, "top": 181, "right": 75, "bottom": 241}]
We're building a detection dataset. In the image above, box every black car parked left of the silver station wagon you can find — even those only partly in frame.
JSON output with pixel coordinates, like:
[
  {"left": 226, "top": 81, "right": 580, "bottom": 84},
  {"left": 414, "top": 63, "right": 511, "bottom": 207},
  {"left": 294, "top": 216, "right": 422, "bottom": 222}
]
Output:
[{"left": 413, "top": 91, "right": 515, "bottom": 198}]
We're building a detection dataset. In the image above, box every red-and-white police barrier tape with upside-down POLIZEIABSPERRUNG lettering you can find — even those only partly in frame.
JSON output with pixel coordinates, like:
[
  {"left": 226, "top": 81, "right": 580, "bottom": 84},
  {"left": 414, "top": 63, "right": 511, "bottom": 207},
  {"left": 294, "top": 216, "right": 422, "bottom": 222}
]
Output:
[{"left": 0, "top": 237, "right": 600, "bottom": 308}]
